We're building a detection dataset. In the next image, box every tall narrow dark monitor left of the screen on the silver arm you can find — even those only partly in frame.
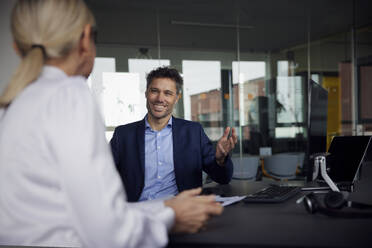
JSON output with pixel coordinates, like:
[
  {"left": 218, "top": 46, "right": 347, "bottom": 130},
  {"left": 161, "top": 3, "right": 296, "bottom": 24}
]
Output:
[{"left": 304, "top": 80, "right": 328, "bottom": 181}]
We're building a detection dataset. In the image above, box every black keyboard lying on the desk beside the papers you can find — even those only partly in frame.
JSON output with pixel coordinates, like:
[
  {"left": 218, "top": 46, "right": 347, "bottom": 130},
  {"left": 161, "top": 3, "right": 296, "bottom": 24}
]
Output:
[{"left": 243, "top": 185, "right": 301, "bottom": 203}]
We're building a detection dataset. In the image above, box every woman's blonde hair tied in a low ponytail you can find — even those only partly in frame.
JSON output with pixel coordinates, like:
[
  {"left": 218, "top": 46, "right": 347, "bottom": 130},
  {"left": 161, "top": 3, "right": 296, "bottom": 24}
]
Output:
[{"left": 0, "top": 0, "right": 95, "bottom": 107}]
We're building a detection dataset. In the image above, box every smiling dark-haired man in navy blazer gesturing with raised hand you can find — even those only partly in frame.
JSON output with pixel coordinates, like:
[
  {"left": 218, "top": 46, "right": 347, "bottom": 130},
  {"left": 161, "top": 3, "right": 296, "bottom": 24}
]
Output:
[{"left": 110, "top": 67, "right": 237, "bottom": 201}]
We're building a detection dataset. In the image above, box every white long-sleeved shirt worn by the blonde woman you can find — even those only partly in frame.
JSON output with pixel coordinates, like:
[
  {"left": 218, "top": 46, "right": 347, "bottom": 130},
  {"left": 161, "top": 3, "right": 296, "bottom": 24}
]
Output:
[{"left": 0, "top": 66, "right": 174, "bottom": 247}]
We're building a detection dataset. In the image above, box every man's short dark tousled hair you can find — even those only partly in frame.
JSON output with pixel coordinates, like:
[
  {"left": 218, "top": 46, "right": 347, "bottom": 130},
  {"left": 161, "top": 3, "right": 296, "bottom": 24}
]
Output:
[{"left": 146, "top": 66, "right": 183, "bottom": 94}]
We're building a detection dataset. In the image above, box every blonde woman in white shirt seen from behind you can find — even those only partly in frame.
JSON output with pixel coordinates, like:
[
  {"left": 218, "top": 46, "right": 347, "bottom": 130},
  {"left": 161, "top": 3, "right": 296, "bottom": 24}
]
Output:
[{"left": 0, "top": 0, "right": 222, "bottom": 247}]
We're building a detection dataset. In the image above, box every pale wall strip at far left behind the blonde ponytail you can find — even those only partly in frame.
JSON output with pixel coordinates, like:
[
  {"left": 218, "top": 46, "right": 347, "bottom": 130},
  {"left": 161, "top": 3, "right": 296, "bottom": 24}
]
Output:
[{"left": 0, "top": 0, "right": 19, "bottom": 92}]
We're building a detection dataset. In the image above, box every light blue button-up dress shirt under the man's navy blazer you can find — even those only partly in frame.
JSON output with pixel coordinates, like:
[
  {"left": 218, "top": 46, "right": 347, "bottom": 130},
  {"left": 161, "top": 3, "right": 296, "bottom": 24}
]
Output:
[{"left": 139, "top": 116, "right": 178, "bottom": 201}]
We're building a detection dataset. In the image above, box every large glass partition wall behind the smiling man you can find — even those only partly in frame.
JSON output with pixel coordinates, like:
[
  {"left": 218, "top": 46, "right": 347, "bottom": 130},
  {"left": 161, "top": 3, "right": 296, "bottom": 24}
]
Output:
[{"left": 88, "top": 0, "right": 372, "bottom": 182}]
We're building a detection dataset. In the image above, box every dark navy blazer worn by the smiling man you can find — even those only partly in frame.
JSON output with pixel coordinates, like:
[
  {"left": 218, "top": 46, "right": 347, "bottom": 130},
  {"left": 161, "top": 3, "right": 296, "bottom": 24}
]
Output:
[{"left": 110, "top": 117, "right": 233, "bottom": 202}]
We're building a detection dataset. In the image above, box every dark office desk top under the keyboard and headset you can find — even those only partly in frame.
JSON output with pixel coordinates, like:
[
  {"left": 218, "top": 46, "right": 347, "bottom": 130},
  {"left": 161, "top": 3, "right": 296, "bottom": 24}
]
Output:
[{"left": 169, "top": 180, "right": 372, "bottom": 247}]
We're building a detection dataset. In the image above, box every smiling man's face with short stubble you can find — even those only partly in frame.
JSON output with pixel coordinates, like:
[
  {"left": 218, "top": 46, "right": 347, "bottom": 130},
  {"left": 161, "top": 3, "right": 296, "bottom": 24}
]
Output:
[{"left": 145, "top": 78, "right": 178, "bottom": 120}]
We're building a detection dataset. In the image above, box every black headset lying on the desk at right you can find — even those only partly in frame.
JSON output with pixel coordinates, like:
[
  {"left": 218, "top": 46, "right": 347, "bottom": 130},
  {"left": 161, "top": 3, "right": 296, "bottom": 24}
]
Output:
[{"left": 303, "top": 191, "right": 372, "bottom": 218}]
